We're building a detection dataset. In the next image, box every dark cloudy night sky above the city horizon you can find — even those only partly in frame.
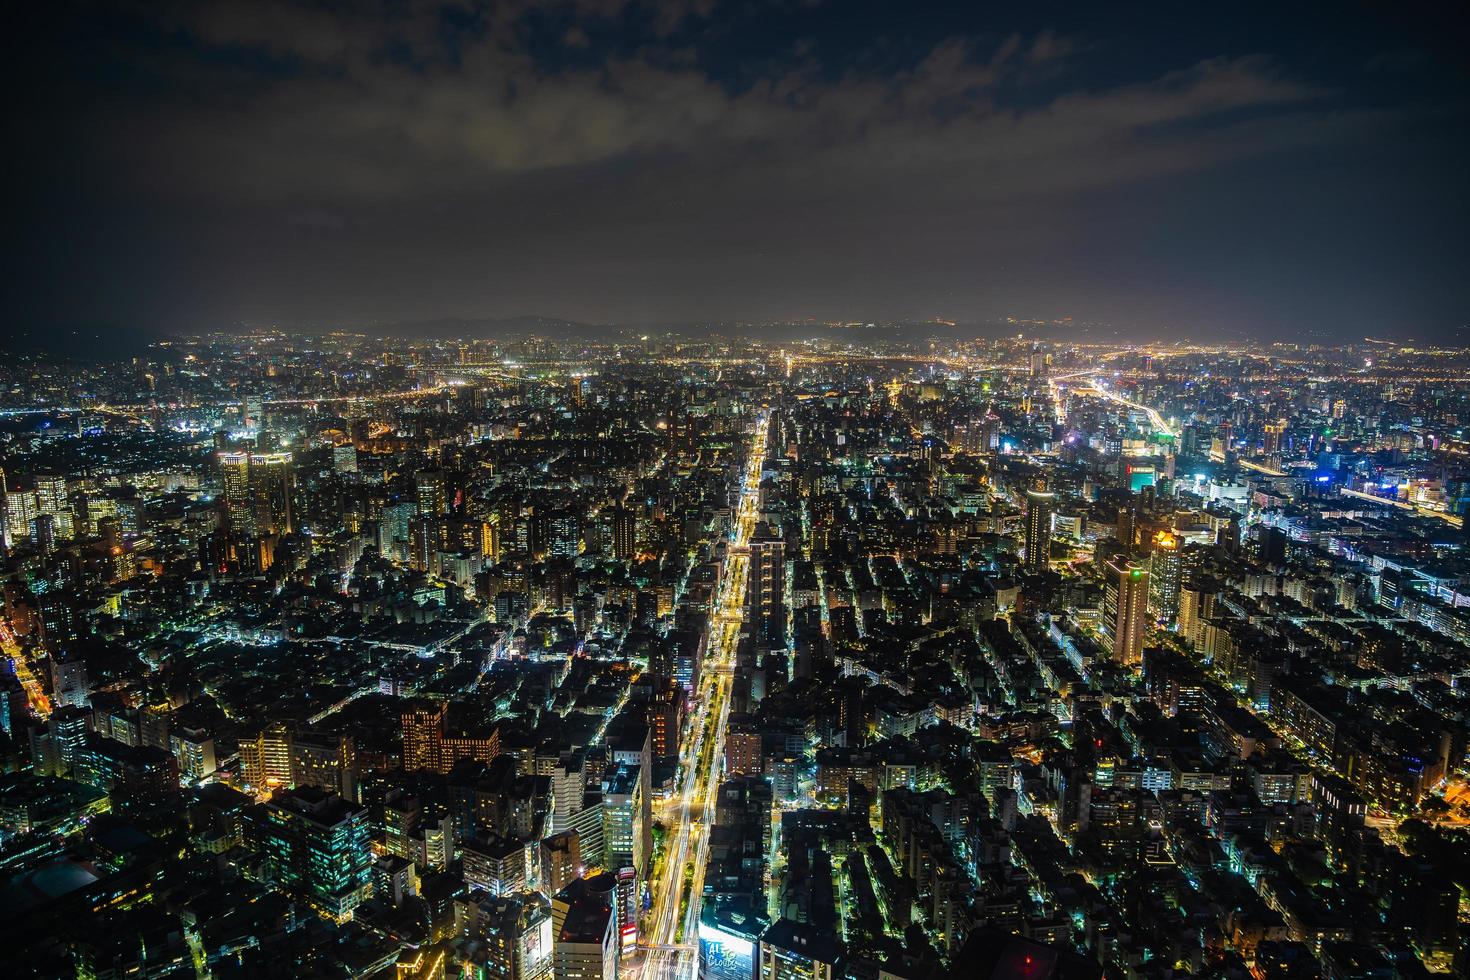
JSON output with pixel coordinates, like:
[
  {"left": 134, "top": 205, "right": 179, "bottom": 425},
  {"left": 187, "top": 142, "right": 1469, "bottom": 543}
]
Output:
[{"left": 3, "top": 0, "right": 1470, "bottom": 342}]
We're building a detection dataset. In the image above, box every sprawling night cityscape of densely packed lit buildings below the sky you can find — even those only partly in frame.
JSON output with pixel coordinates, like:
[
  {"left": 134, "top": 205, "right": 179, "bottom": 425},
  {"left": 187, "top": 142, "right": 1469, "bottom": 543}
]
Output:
[{"left": 0, "top": 331, "right": 1470, "bottom": 980}]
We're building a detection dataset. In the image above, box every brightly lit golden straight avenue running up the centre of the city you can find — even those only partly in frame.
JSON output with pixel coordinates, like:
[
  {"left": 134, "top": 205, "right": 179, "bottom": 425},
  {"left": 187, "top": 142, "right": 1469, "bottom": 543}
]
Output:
[{"left": 634, "top": 413, "right": 769, "bottom": 980}]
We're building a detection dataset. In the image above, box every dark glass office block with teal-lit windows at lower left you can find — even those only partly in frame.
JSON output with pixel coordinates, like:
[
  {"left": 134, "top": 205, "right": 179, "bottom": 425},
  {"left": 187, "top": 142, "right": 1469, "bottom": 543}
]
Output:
[{"left": 257, "top": 786, "right": 372, "bottom": 921}]
